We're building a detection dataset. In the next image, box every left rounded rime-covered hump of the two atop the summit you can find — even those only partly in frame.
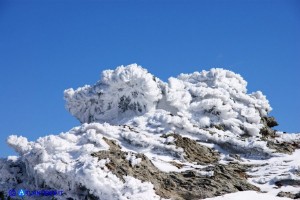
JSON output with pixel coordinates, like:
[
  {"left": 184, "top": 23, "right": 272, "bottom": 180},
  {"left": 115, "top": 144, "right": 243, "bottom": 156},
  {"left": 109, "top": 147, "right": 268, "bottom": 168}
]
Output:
[{"left": 64, "top": 64, "right": 161, "bottom": 123}]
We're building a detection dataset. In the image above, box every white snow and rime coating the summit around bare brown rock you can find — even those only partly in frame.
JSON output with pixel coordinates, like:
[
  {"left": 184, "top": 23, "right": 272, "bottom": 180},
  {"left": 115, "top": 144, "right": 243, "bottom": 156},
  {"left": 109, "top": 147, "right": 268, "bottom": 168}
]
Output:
[{"left": 0, "top": 64, "right": 300, "bottom": 200}]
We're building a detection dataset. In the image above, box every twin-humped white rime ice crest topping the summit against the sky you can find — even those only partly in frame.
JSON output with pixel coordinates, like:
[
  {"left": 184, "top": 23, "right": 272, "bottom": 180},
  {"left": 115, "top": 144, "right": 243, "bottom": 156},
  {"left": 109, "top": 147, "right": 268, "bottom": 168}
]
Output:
[{"left": 65, "top": 64, "right": 271, "bottom": 136}]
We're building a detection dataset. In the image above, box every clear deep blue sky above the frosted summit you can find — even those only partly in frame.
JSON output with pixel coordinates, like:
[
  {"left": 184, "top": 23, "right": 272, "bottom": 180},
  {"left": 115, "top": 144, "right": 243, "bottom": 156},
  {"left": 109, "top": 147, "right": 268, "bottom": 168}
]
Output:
[{"left": 0, "top": 0, "right": 300, "bottom": 157}]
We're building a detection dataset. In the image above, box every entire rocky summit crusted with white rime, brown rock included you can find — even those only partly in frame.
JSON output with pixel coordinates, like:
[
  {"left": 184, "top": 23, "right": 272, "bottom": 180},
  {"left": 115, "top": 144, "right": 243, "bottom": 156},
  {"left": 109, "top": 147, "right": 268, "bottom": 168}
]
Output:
[{"left": 0, "top": 64, "right": 300, "bottom": 200}]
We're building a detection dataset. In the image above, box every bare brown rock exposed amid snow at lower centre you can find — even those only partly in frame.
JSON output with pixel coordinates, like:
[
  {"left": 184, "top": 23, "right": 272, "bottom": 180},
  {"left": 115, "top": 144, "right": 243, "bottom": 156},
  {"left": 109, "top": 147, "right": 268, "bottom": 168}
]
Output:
[{"left": 92, "top": 138, "right": 259, "bottom": 199}]
